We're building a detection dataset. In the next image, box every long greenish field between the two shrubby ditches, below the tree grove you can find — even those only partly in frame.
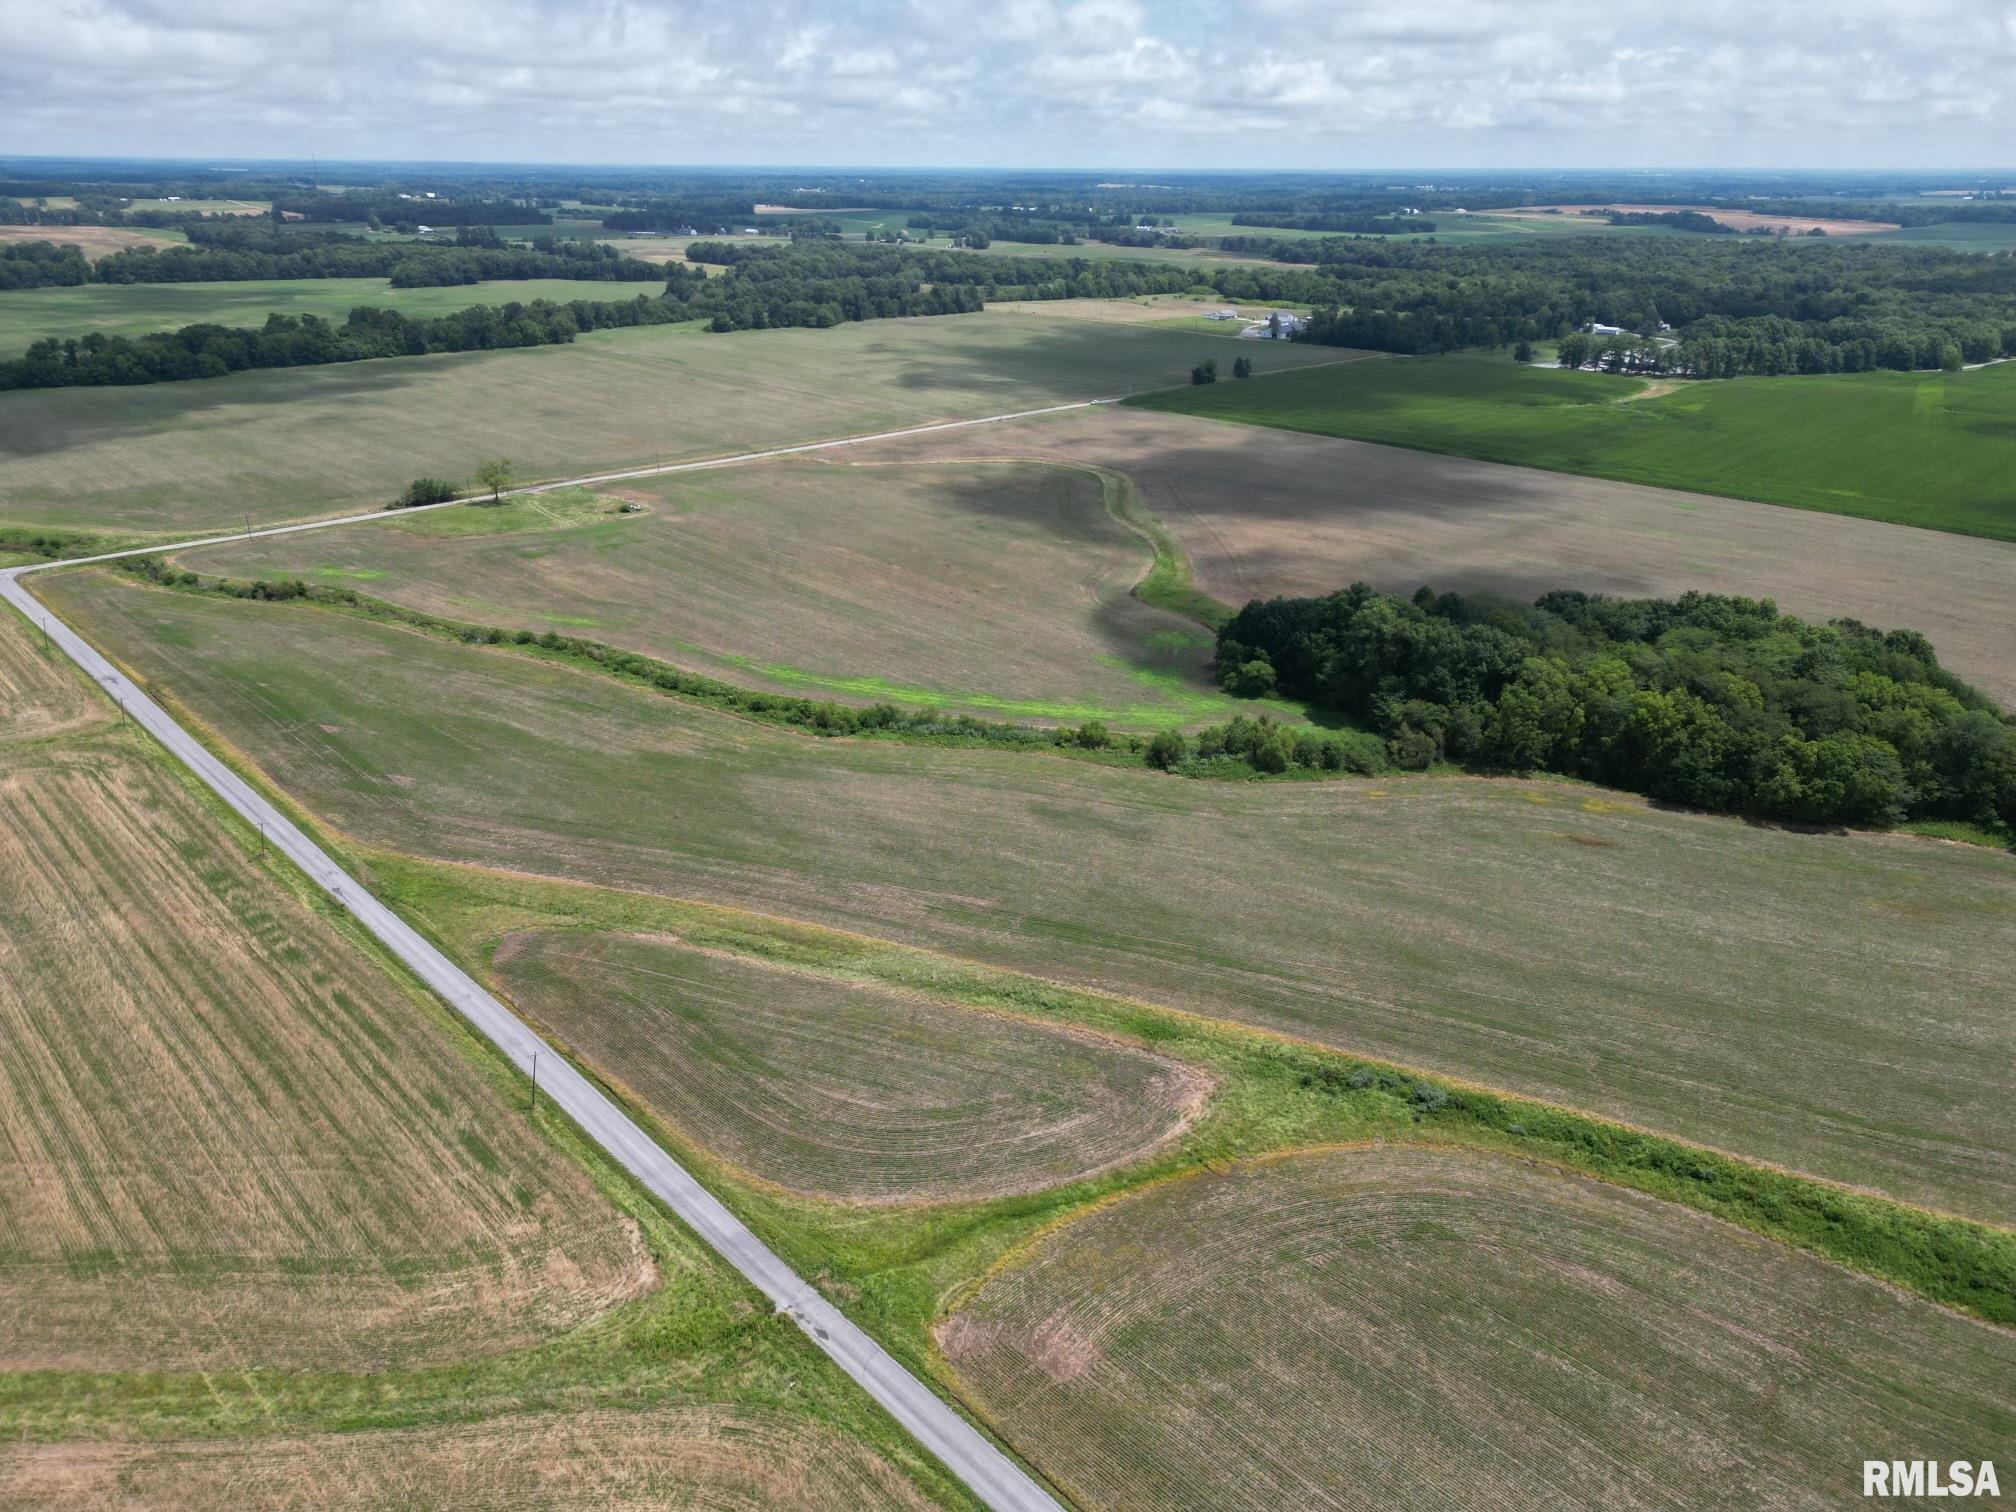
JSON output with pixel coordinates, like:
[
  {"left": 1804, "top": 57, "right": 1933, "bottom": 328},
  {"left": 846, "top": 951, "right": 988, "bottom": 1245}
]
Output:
[{"left": 42, "top": 573, "right": 2016, "bottom": 1222}]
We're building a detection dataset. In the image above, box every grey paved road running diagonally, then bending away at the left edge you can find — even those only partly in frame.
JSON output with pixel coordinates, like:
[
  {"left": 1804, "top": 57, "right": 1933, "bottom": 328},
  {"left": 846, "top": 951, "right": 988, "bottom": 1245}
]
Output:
[{"left": 0, "top": 399, "right": 1088, "bottom": 1512}]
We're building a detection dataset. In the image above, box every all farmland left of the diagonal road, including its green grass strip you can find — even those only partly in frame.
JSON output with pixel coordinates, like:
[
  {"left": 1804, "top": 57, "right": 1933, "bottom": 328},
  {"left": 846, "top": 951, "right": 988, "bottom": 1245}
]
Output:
[{"left": 0, "top": 611, "right": 983, "bottom": 1506}]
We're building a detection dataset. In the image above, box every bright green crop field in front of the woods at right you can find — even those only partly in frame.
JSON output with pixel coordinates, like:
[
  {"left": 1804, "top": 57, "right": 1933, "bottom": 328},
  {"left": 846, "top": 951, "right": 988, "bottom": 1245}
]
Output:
[{"left": 1141, "top": 353, "right": 2016, "bottom": 540}]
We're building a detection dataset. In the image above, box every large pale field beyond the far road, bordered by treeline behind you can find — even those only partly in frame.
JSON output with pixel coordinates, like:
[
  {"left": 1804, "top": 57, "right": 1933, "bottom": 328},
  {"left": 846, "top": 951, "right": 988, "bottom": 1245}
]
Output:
[{"left": 0, "top": 312, "right": 1341, "bottom": 534}]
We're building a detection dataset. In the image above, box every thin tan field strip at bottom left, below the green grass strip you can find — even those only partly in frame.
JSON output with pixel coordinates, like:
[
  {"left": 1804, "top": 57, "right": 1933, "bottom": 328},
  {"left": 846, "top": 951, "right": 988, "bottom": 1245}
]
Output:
[{"left": 0, "top": 1407, "right": 931, "bottom": 1512}]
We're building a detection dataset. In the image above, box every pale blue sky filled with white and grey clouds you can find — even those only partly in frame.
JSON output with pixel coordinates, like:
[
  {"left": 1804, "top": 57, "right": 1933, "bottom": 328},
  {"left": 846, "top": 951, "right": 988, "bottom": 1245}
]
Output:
[{"left": 0, "top": 0, "right": 2016, "bottom": 169}]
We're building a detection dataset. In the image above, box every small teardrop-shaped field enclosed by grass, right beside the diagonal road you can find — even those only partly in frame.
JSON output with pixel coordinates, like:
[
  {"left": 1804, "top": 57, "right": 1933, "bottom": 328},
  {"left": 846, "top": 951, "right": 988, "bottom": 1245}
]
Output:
[{"left": 494, "top": 933, "right": 1208, "bottom": 1202}]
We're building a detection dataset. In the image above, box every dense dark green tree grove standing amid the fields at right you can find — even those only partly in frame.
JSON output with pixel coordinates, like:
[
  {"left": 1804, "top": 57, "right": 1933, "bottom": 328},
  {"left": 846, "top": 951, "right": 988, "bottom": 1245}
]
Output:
[{"left": 1218, "top": 583, "right": 2016, "bottom": 829}]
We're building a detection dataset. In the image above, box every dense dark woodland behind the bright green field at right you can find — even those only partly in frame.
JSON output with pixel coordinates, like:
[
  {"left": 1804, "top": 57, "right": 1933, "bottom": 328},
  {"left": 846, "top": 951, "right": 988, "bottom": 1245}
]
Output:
[{"left": 1300, "top": 236, "right": 2016, "bottom": 377}]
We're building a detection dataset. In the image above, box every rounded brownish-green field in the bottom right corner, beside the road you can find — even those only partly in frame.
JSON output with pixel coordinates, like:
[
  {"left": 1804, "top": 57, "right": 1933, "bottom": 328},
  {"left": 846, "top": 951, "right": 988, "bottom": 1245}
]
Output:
[{"left": 939, "top": 1147, "right": 2016, "bottom": 1508}]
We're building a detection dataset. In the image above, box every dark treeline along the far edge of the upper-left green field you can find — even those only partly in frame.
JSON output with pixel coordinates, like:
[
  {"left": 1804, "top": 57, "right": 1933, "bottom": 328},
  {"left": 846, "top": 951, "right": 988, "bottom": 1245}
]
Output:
[{"left": 0, "top": 226, "right": 665, "bottom": 288}]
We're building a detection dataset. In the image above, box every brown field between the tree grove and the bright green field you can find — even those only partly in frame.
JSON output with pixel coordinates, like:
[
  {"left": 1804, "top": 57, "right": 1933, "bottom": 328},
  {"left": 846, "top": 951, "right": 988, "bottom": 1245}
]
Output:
[{"left": 871, "top": 407, "right": 2016, "bottom": 706}]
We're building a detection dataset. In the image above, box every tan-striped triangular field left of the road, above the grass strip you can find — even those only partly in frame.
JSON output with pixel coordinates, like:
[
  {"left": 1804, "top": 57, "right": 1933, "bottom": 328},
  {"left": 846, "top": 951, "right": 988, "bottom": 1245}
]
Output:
[{"left": 0, "top": 615, "right": 655, "bottom": 1371}]
